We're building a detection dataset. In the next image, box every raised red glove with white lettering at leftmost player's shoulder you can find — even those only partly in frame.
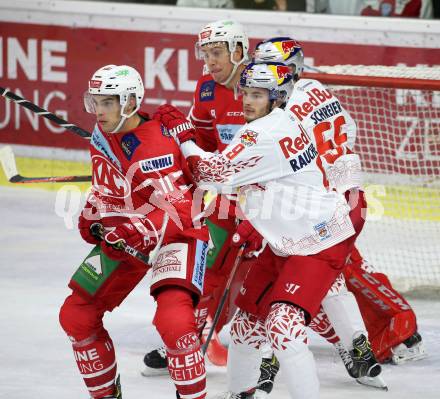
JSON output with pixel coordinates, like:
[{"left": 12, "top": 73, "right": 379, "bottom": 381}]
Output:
[{"left": 153, "top": 104, "right": 196, "bottom": 144}]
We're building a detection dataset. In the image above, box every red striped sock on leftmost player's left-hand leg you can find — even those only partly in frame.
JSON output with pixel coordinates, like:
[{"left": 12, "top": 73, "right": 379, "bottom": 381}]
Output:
[{"left": 72, "top": 329, "right": 117, "bottom": 398}]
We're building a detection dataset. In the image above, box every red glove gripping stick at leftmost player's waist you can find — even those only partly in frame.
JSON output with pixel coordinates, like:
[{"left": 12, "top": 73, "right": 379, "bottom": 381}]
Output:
[{"left": 101, "top": 223, "right": 157, "bottom": 261}]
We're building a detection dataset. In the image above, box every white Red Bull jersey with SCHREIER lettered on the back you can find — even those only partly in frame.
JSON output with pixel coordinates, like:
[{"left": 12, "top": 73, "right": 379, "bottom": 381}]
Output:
[{"left": 286, "top": 79, "right": 362, "bottom": 193}]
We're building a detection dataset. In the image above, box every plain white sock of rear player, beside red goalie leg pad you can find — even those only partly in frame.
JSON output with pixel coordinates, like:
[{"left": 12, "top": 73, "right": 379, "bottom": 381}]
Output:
[{"left": 322, "top": 291, "right": 368, "bottom": 350}]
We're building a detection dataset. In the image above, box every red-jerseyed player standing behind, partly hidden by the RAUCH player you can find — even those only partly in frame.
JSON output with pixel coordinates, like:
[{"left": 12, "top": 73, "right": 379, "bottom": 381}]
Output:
[{"left": 143, "top": 20, "right": 249, "bottom": 376}]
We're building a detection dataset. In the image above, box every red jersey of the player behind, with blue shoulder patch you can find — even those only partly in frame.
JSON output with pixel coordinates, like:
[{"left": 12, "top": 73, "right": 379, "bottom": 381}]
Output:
[{"left": 189, "top": 75, "right": 245, "bottom": 152}]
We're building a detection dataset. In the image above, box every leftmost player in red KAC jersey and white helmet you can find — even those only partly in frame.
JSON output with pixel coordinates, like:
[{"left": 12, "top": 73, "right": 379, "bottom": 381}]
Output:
[{"left": 60, "top": 65, "right": 208, "bottom": 399}]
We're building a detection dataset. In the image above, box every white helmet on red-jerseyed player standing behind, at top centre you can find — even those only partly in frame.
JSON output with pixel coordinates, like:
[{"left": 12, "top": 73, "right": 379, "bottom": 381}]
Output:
[{"left": 196, "top": 20, "right": 249, "bottom": 64}]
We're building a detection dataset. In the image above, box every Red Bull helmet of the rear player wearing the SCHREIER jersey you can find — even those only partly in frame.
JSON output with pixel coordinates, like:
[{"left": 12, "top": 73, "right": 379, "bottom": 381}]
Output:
[{"left": 253, "top": 37, "right": 304, "bottom": 79}]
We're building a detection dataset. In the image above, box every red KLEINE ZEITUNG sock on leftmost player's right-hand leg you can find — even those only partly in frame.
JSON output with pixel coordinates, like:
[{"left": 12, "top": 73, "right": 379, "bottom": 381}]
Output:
[{"left": 154, "top": 288, "right": 206, "bottom": 399}]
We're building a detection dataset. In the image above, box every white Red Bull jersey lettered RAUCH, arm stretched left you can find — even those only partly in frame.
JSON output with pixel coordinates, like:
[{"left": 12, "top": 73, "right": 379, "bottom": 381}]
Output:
[{"left": 182, "top": 108, "right": 354, "bottom": 256}]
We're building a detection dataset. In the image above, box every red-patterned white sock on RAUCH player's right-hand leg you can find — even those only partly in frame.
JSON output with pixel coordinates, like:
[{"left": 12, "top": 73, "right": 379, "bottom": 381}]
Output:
[{"left": 266, "top": 303, "right": 319, "bottom": 399}]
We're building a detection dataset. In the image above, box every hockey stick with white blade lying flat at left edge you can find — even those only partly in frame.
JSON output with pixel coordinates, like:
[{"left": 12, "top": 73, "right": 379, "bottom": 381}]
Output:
[{"left": 0, "top": 146, "right": 92, "bottom": 183}]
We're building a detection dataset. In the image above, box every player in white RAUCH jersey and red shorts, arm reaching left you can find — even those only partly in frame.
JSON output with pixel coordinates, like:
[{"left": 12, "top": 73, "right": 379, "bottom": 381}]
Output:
[{"left": 153, "top": 63, "right": 381, "bottom": 399}]
